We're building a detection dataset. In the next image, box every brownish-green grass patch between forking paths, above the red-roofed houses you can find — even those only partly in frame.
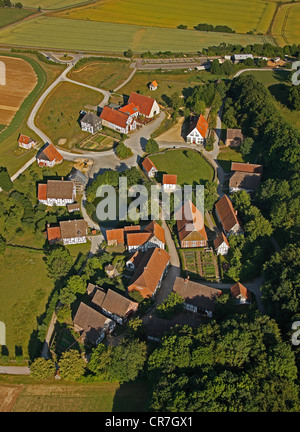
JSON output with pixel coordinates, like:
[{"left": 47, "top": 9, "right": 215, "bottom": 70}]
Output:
[{"left": 68, "top": 61, "right": 132, "bottom": 90}]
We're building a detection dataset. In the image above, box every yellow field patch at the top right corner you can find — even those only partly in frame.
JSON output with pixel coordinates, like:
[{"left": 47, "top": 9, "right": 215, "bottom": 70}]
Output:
[{"left": 271, "top": 2, "right": 300, "bottom": 46}]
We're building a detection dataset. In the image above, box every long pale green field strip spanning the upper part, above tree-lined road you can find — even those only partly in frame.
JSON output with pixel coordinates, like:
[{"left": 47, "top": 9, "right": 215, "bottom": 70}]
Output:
[{"left": 0, "top": 16, "right": 273, "bottom": 53}]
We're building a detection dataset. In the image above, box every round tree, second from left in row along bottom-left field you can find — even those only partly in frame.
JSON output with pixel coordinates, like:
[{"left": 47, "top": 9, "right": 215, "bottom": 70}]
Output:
[{"left": 58, "top": 350, "right": 86, "bottom": 381}]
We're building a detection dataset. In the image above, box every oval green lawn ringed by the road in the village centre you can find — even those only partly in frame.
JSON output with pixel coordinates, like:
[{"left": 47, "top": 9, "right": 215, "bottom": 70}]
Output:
[{"left": 150, "top": 150, "right": 214, "bottom": 186}]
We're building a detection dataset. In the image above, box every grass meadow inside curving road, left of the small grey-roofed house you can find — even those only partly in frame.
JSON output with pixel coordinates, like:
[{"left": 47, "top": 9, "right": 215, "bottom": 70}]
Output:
[{"left": 36, "top": 82, "right": 103, "bottom": 148}]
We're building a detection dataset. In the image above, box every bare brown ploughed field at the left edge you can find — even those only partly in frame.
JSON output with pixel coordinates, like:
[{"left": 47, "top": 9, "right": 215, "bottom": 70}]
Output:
[{"left": 0, "top": 56, "right": 37, "bottom": 125}]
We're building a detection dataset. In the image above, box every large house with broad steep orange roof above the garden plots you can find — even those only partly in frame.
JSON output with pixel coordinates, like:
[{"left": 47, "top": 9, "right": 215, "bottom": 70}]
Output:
[{"left": 176, "top": 201, "right": 207, "bottom": 248}]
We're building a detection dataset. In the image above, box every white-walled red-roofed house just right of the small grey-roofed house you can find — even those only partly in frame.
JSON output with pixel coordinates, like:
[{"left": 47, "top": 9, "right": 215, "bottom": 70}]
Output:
[{"left": 100, "top": 106, "right": 136, "bottom": 134}]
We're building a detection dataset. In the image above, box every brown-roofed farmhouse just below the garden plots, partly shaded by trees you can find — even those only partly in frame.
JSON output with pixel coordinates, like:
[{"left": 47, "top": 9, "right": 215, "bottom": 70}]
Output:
[{"left": 173, "top": 276, "right": 222, "bottom": 318}]
